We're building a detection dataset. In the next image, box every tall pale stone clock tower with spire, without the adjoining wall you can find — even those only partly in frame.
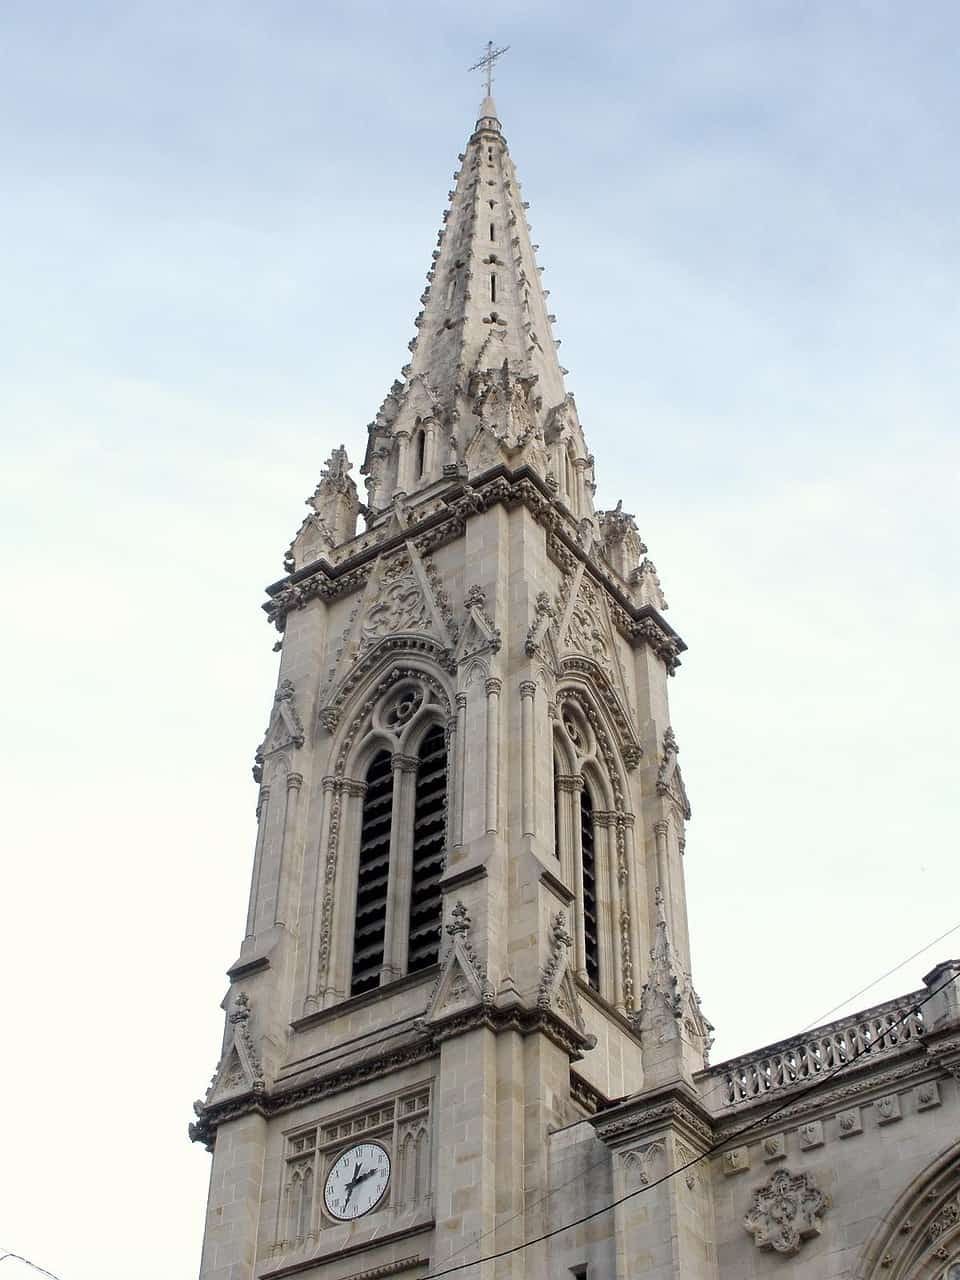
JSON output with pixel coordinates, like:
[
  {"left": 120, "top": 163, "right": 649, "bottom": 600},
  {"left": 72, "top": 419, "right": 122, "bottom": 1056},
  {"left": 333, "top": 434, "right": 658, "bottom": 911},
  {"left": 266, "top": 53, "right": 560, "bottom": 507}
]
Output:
[{"left": 192, "top": 96, "right": 709, "bottom": 1280}]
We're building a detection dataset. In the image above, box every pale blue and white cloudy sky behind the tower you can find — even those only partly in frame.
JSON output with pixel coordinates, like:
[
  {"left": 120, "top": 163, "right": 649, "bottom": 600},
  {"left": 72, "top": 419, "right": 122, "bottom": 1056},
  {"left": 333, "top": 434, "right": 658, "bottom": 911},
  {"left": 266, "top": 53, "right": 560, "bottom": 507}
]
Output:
[{"left": 0, "top": 0, "right": 960, "bottom": 1280}]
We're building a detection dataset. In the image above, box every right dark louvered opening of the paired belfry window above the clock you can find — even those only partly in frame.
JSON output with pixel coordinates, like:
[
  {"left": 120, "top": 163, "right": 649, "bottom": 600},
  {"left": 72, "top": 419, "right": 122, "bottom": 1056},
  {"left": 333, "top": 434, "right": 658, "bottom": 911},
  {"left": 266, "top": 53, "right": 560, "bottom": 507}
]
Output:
[{"left": 407, "top": 724, "right": 447, "bottom": 973}]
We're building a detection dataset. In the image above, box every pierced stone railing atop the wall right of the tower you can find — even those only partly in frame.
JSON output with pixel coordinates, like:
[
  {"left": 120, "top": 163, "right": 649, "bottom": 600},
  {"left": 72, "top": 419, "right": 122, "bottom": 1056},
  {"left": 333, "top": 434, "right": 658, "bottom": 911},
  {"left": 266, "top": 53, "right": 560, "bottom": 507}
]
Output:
[{"left": 709, "top": 989, "right": 929, "bottom": 1107}]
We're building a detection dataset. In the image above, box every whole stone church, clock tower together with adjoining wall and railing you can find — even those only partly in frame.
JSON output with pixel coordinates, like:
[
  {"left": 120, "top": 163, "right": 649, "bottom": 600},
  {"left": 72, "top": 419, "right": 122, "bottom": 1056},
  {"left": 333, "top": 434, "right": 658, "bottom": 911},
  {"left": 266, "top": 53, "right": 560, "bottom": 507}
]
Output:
[{"left": 191, "top": 97, "right": 960, "bottom": 1280}]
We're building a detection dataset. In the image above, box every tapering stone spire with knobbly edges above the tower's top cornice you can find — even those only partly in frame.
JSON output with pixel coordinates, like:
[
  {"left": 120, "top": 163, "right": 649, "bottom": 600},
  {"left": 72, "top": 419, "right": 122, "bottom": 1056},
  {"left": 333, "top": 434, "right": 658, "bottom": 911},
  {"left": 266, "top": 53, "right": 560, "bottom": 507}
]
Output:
[{"left": 361, "top": 96, "right": 593, "bottom": 517}]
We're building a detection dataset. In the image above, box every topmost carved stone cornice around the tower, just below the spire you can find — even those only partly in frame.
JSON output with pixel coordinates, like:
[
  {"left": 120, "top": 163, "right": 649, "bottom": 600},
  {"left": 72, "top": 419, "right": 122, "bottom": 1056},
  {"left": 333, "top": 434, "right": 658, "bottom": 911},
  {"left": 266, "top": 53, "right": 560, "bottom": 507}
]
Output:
[{"left": 264, "top": 465, "right": 686, "bottom": 671}]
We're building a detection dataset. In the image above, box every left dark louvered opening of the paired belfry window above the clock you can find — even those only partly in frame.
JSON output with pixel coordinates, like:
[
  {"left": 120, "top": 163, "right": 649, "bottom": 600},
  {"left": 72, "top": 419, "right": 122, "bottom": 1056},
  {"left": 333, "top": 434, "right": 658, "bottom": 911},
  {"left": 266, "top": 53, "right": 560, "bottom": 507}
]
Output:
[{"left": 349, "top": 751, "right": 393, "bottom": 996}]
